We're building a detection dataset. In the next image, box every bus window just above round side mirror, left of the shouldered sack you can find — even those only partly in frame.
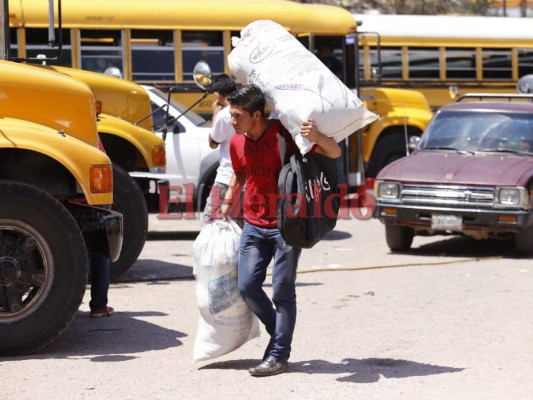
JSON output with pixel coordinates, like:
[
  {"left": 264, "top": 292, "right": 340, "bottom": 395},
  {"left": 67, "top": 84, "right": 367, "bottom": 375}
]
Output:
[{"left": 181, "top": 31, "right": 225, "bottom": 81}]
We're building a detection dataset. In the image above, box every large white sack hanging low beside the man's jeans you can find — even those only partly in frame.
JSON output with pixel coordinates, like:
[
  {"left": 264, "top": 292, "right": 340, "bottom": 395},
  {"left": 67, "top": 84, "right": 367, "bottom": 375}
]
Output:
[{"left": 193, "top": 220, "right": 259, "bottom": 361}]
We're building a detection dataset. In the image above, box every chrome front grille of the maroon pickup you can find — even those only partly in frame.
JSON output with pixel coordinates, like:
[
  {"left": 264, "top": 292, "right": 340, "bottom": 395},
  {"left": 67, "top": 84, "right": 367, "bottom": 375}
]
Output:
[{"left": 401, "top": 184, "right": 494, "bottom": 208}]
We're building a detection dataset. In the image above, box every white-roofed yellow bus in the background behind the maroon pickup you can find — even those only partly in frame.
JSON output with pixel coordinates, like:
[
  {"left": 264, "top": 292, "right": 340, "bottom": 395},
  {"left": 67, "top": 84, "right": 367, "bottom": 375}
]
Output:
[{"left": 354, "top": 14, "right": 533, "bottom": 109}]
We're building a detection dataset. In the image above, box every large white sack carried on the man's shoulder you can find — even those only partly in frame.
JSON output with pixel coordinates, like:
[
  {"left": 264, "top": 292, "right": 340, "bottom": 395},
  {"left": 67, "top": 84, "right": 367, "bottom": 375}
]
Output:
[{"left": 228, "top": 20, "right": 378, "bottom": 154}]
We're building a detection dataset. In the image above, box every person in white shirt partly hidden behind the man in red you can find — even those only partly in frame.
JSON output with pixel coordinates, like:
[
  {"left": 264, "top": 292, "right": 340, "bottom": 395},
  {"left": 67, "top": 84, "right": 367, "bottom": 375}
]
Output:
[{"left": 203, "top": 74, "right": 236, "bottom": 224}]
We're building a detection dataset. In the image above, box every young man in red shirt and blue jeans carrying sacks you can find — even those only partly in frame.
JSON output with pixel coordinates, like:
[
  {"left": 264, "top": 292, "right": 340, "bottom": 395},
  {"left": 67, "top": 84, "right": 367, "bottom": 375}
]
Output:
[{"left": 220, "top": 85, "right": 341, "bottom": 376}]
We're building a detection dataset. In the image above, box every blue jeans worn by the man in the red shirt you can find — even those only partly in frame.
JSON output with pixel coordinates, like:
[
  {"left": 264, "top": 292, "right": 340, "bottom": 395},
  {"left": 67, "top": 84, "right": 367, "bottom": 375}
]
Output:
[{"left": 238, "top": 222, "right": 302, "bottom": 360}]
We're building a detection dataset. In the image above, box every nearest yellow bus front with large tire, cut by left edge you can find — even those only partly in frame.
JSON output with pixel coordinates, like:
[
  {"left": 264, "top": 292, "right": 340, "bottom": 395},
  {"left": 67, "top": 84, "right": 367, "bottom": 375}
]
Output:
[{"left": 0, "top": 61, "right": 122, "bottom": 356}]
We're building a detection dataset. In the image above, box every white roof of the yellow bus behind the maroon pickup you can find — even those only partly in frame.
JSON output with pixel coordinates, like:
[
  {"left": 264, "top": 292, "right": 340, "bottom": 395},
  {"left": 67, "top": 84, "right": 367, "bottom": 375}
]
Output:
[{"left": 353, "top": 14, "right": 533, "bottom": 47}]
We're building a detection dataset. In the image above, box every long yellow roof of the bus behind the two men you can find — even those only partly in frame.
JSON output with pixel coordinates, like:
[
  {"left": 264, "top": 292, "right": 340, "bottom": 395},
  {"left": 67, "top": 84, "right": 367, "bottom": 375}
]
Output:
[{"left": 9, "top": 0, "right": 355, "bottom": 35}]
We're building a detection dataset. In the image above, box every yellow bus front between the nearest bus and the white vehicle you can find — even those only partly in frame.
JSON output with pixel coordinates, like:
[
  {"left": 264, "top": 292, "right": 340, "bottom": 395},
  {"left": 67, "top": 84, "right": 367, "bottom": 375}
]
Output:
[{"left": 41, "top": 65, "right": 166, "bottom": 279}]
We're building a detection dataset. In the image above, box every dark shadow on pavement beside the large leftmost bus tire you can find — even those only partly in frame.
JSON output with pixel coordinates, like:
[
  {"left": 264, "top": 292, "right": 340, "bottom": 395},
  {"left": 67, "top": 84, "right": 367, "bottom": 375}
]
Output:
[{"left": 23, "top": 311, "right": 187, "bottom": 362}]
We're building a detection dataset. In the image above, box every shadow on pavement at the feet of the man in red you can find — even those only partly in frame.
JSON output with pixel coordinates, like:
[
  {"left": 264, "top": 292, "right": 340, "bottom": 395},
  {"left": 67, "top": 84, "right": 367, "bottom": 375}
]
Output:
[{"left": 199, "top": 358, "right": 464, "bottom": 383}]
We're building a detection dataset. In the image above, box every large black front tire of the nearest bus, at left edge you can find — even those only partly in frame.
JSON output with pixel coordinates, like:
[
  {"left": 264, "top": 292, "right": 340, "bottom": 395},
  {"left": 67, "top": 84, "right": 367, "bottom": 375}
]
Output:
[{"left": 0, "top": 181, "right": 88, "bottom": 356}]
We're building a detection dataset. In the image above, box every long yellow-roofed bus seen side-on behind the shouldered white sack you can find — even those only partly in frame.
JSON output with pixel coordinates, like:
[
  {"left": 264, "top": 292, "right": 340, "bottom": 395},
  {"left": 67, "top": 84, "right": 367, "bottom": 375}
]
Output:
[{"left": 9, "top": 0, "right": 431, "bottom": 185}]
